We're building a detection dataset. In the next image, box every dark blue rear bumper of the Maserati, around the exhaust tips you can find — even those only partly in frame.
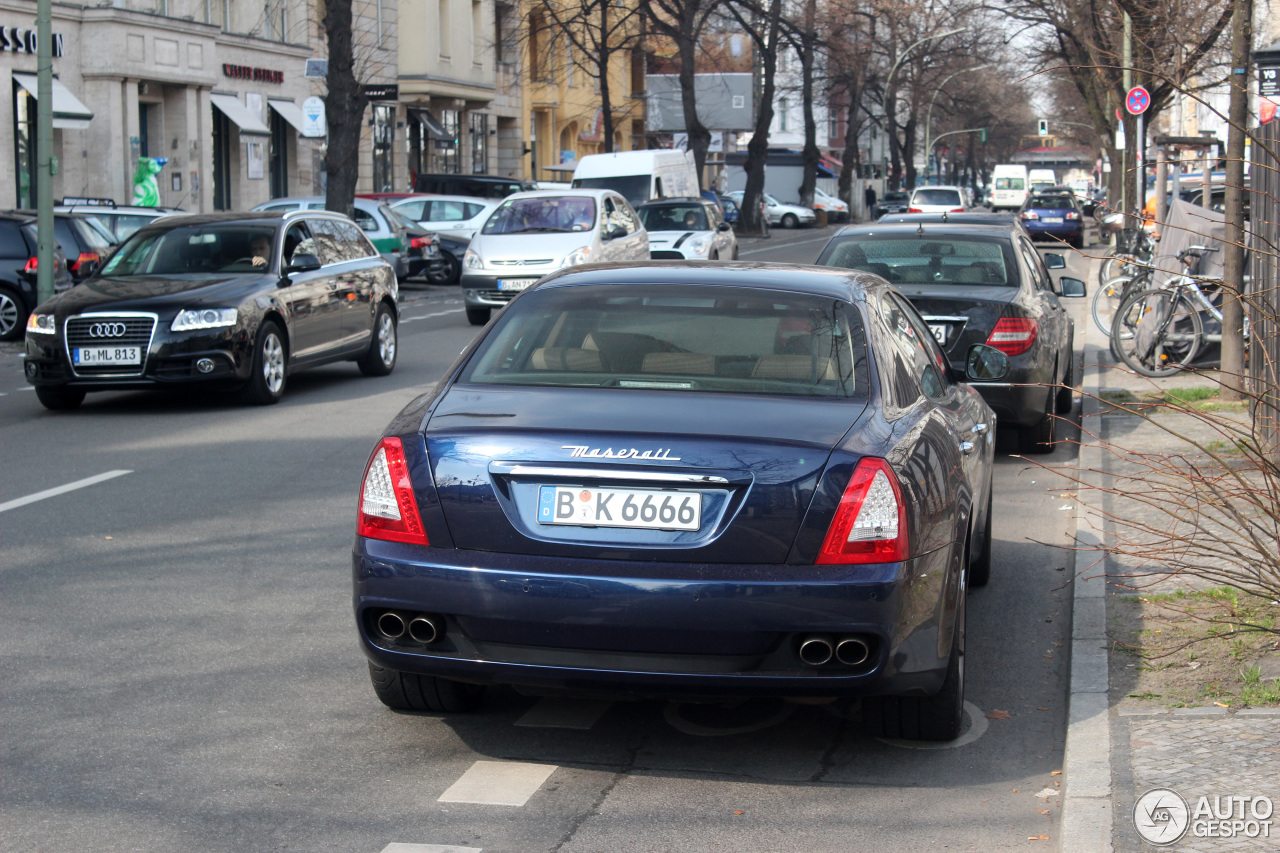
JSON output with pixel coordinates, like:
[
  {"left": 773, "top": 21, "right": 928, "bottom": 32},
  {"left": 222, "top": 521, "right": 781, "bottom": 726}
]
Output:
[{"left": 352, "top": 538, "right": 951, "bottom": 697}]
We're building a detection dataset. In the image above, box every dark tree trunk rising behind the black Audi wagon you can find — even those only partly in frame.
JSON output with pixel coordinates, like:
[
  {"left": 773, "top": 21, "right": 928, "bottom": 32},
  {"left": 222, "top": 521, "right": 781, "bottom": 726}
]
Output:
[{"left": 324, "top": 0, "right": 369, "bottom": 216}]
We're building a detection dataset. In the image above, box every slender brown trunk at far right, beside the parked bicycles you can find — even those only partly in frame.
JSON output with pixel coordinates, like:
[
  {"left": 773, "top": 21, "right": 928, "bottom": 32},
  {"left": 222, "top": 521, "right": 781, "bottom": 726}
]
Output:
[{"left": 1206, "top": 0, "right": 1253, "bottom": 401}]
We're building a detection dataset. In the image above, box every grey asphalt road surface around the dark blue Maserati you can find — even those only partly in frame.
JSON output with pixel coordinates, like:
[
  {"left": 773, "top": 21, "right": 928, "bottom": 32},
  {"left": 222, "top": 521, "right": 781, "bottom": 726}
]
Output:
[{"left": 0, "top": 229, "right": 1092, "bottom": 853}]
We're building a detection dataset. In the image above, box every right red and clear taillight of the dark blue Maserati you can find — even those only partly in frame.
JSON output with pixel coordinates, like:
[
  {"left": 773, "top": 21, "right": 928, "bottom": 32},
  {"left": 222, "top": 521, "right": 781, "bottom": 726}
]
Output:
[{"left": 814, "top": 456, "right": 908, "bottom": 565}]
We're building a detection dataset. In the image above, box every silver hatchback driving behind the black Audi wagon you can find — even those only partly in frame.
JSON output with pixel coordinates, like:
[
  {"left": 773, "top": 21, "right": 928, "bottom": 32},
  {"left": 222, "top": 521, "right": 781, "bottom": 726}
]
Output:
[{"left": 462, "top": 190, "right": 649, "bottom": 325}]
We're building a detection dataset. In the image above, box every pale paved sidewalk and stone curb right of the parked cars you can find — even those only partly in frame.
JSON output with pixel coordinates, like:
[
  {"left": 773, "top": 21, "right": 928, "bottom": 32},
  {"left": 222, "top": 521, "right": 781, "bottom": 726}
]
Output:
[{"left": 1059, "top": 250, "right": 1280, "bottom": 853}]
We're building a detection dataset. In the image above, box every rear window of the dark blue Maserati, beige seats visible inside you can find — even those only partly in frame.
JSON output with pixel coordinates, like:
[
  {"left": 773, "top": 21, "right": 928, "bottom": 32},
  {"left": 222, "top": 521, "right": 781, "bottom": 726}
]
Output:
[{"left": 460, "top": 284, "right": 867, "bottom": 397}]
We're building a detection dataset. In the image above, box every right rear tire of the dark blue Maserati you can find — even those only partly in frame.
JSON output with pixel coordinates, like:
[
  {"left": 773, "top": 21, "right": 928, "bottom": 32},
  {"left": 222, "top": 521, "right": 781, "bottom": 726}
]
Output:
[{"left": 863, "top": 545, "right": 968, "bottom": 740}]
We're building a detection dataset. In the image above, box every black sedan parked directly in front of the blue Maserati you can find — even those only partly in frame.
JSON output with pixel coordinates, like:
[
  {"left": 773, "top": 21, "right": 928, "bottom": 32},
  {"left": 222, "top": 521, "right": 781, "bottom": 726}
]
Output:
[{"left": 815, "top": 222, "right": 1085, "bottom": 453}]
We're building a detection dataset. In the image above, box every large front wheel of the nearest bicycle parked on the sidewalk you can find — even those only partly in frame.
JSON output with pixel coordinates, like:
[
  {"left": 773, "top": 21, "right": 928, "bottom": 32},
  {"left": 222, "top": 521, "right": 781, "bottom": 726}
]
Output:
[{"left": 1111, "top": 288, "right": 1204, "bottom": 377}]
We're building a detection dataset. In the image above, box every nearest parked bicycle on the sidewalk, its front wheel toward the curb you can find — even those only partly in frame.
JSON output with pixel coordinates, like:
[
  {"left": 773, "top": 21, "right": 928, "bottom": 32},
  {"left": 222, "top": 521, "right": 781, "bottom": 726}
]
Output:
[{"left": 1111, "top": 246, "right": 1228, "bottom": 377}]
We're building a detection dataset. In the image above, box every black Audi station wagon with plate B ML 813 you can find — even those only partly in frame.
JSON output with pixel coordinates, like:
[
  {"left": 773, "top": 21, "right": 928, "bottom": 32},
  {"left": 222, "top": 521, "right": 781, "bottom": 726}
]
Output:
[{"left": 26, "top": 210, "right": 398, "bottom": 410}]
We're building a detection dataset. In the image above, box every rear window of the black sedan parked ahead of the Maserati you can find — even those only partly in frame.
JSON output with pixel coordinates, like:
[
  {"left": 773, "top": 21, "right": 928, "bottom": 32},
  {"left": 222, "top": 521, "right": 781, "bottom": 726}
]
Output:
[{"left": 818, "top": 234, "right": 1018, "bottom": 287}]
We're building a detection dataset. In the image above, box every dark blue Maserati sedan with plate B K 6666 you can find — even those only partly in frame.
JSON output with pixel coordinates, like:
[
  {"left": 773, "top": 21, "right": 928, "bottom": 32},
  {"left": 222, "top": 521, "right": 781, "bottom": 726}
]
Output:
[{"left": 352, "top": 263, "right": 1007, "bottom": 740}]
